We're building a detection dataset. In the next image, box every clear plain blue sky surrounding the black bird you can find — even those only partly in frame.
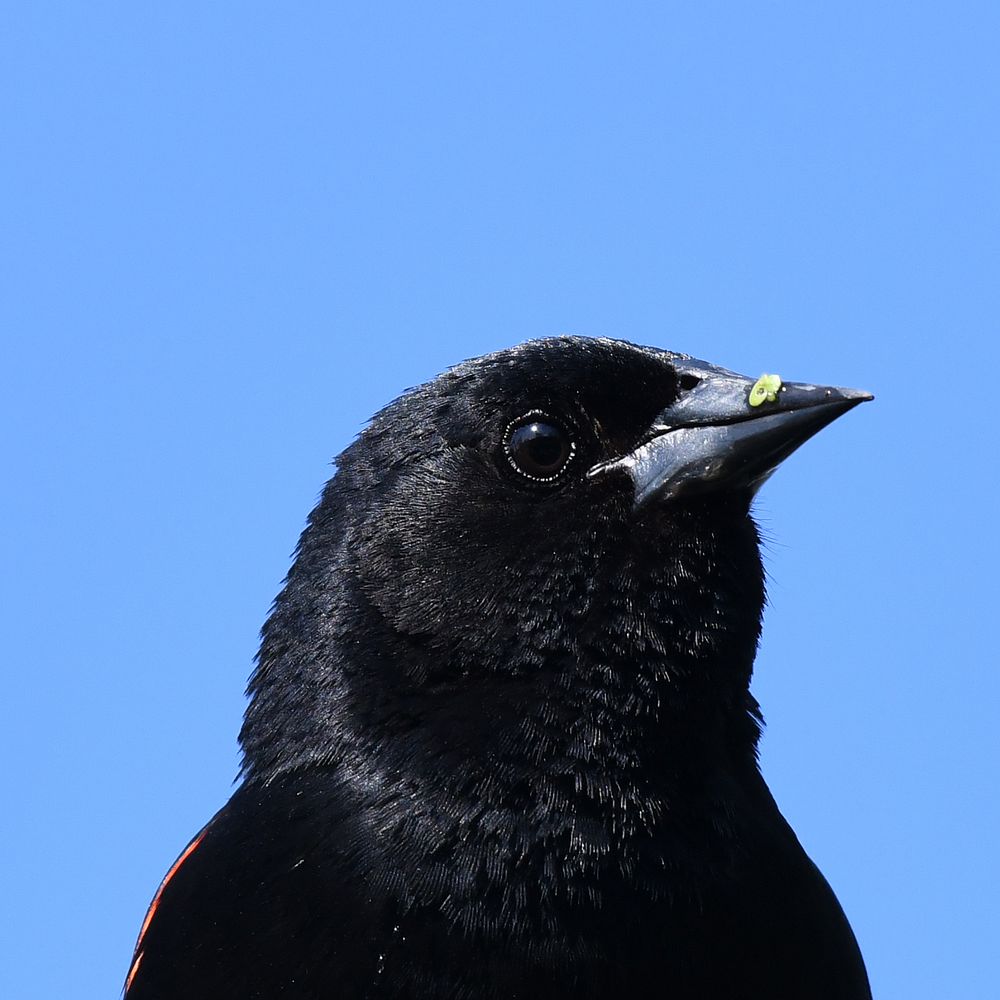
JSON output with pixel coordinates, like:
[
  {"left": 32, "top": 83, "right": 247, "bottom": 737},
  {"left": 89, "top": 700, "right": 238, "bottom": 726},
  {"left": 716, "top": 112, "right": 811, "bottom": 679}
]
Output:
[{"left": 0, "top": 0, "right": 1000, "bottom": 1000}]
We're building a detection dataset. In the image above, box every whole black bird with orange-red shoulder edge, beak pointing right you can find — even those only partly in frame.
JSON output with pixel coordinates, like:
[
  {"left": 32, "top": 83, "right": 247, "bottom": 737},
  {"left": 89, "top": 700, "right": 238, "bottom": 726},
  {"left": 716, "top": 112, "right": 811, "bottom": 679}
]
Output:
[{"left": 125, "top": 337, "right": 871, "bottom": 1000}]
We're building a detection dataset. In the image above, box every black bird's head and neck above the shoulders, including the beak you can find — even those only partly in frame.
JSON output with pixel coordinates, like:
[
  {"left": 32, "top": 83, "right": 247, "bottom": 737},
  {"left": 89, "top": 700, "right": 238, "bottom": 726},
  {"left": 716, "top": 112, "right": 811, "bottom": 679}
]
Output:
[{"left": 241, "top": 337, "right": 870, "bottom": 786}]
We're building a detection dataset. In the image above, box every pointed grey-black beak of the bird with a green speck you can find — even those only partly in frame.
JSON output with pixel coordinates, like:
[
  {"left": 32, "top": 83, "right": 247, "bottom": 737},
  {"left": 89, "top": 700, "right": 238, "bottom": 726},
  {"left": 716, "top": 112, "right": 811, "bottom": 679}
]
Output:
[{"left": 588, "top": 358, "right": 874, "bottom": 507}]
